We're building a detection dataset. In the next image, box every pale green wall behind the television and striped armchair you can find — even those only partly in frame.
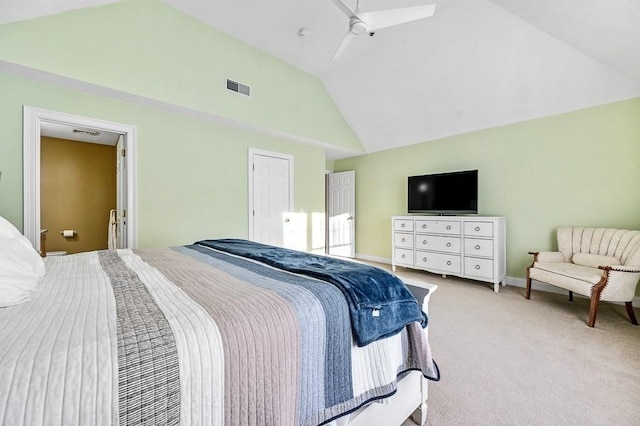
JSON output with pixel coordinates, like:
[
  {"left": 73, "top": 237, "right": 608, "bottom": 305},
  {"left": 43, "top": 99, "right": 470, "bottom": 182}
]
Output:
[{"left": 334, "top": 99, "right": 640, "bottom": 277}]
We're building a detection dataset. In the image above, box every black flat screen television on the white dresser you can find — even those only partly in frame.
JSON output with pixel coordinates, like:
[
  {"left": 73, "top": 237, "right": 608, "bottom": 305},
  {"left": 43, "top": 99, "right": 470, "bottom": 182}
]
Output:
[{"left": 407, "top": 170, "right": 478, "bottom": 215}]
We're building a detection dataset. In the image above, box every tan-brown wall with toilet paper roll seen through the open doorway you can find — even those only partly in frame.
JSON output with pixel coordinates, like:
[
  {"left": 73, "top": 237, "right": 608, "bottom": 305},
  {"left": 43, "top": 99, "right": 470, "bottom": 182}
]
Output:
[{"left": 40, "top": 137, "right": 116, "bottom": 253}]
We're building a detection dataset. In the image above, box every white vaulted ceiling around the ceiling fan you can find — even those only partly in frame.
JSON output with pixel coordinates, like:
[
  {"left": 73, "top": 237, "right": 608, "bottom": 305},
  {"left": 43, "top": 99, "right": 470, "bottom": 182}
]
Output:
[{"left": 0, "top": 0, "right": 640, "bottom": 157}]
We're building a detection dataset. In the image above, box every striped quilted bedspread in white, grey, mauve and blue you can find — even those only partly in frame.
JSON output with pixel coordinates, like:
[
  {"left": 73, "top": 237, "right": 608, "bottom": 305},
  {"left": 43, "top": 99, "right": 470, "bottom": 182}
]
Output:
[{"left": 0, "top": 246, "right": 439, "bottom": 426}]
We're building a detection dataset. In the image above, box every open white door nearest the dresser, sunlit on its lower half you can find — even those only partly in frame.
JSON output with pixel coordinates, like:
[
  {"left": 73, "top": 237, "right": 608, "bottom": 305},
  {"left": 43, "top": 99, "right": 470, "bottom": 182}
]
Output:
[{"left": 327, "top": 170, "right": 356, "bottom": 257}]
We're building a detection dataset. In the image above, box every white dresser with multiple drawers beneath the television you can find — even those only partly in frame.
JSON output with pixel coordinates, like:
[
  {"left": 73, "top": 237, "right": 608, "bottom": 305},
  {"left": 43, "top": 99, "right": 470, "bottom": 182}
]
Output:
[{"left": 391, "top": 216, "right": 507, "bottom": 292}]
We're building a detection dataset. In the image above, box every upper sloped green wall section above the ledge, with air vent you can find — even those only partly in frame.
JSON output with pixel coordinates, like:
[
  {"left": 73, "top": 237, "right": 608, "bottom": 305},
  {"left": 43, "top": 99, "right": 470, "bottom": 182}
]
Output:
[{"left": 0, "top": 0, "right": 364, "bottom": 153}]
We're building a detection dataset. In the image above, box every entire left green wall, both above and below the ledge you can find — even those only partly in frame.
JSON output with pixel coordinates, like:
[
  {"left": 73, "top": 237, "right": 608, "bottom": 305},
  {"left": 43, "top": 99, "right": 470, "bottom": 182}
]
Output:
[{"left": 0, "top": 0, "right": 363, "bottom": 248}]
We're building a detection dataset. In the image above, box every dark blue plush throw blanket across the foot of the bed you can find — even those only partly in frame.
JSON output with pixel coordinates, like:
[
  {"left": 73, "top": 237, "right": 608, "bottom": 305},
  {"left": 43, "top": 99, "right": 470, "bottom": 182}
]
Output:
[{"left": 195, "top": 239, "right": 427, "bottom": 346}]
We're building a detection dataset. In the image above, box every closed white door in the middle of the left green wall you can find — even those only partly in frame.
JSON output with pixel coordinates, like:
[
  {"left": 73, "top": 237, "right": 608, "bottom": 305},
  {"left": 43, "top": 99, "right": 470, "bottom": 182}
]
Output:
[{"left": 249, "top": 149, "right": 293, "bottom": 247}]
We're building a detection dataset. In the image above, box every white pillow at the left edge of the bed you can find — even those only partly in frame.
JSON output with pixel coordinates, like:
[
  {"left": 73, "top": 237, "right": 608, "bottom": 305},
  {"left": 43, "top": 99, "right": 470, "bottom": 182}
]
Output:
[{"left": 0, "top": 216, "right": 45, "bottom": 308}]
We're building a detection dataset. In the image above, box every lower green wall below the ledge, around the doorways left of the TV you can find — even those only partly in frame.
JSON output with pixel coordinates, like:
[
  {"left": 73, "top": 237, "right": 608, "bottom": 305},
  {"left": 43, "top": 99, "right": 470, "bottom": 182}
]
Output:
[{"left": 0, "top": 74, "right": 325, "bottom": 247}]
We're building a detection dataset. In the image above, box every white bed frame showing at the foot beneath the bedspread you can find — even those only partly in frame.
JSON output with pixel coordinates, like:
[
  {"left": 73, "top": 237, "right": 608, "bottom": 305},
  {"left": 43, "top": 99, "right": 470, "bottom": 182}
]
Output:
[{"left": 329, "top": 280, "right": 438, "bottom": 426}]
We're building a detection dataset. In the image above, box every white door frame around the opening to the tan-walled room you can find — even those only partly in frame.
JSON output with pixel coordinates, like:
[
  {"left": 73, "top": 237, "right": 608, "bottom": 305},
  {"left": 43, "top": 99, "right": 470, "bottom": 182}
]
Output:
[{"left": 22, "top": 105, "right": 138, "bottom": 252}]
